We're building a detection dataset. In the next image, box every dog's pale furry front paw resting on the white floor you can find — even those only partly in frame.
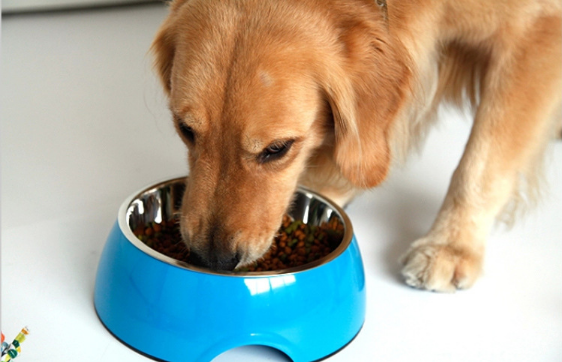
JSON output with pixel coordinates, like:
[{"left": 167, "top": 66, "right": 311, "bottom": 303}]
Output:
[{"left": 401, "top": 239, "right": 482, "bottom": 292}]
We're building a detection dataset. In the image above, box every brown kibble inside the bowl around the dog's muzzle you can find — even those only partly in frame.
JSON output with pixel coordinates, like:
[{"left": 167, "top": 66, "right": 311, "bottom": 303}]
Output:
[{"left": 133, "top": 215, "right": 343, "bottom": 272}]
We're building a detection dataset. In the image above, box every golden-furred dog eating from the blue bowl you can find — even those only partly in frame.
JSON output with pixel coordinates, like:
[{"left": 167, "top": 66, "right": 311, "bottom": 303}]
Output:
[{"left": 151, "top": 0, "right": 562, "bottom": 291}]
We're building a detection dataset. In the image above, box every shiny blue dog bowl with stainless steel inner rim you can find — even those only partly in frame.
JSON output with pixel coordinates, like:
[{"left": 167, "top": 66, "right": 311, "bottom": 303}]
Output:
[{"left": 94, "top": 178, "right": 365, "bottom": 362}]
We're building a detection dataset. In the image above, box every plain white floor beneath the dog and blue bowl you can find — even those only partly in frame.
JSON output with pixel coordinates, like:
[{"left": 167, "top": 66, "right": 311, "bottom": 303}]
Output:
[{"left": 1, "top": 4, "right": 562, "bottom": 362}]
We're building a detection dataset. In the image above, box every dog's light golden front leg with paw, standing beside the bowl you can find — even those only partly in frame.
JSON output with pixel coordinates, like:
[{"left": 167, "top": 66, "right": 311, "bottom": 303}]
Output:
[{"left": 402, "top": 18, "right": 562, "bottom": 291}]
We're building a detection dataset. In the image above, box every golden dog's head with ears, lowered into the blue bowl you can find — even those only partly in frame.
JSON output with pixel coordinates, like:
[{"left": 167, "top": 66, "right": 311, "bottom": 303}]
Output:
[{"left": 152, "top": 0, "right": 408, "bottom": 269}]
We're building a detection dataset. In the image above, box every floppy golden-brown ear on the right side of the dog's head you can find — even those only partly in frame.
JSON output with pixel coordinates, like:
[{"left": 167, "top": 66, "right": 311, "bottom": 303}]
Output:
[{"left": 324, "top": 21, "right": 410, "bottom": 188}]
